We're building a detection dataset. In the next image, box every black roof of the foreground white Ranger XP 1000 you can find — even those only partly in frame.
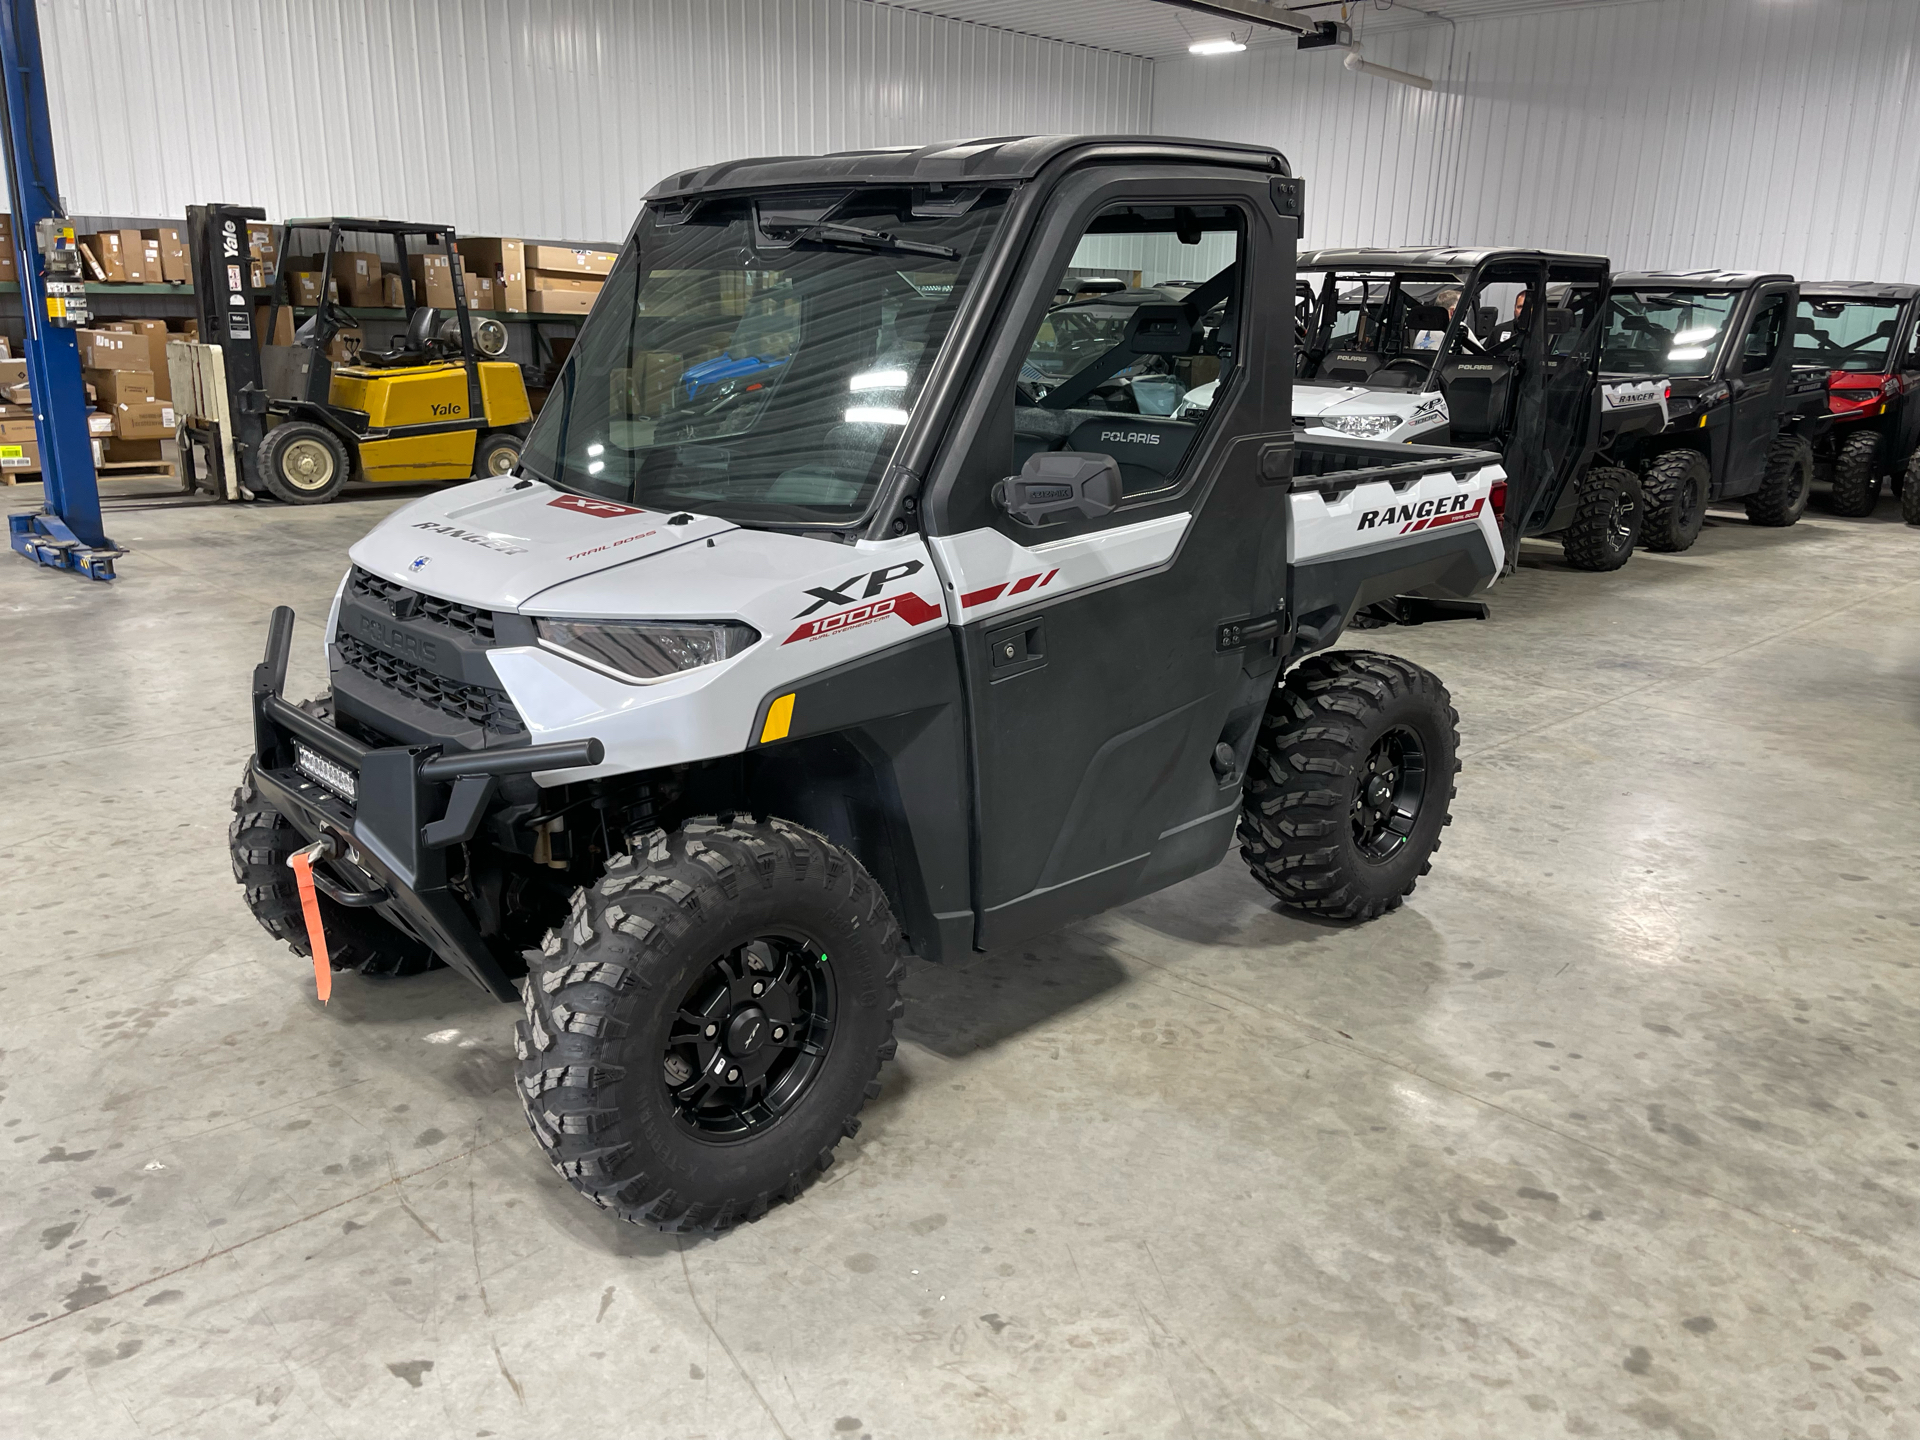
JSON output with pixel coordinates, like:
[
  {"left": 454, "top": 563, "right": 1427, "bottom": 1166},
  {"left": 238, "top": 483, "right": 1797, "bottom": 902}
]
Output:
[{"left": 647, "top": 134, "right": 1292, "bottom": 200}]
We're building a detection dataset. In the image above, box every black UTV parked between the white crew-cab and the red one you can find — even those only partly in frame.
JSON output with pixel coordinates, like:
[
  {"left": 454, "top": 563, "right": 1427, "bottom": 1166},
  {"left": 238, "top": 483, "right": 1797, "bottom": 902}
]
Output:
[{"left": 1601, "top": 271, "right": 1826, "bottom": 551}]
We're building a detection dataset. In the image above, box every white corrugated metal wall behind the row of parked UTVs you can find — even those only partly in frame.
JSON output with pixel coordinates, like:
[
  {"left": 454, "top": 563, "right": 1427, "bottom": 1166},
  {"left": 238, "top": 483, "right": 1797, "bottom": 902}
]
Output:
[{"left": 1154, "top": 0, "right": 1920, "bottom": 280}]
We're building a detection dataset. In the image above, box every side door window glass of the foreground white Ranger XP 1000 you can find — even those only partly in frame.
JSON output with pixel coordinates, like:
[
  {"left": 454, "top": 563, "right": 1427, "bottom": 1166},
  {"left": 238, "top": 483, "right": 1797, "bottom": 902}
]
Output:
[{"left": 1014, "top": 204, "right": 1246, "bottom": 497}]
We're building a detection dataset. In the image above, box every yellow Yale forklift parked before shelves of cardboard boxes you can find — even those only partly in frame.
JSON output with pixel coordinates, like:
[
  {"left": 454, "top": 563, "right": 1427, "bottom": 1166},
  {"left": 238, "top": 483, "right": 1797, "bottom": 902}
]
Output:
[{"left": 169, "top": 205, "right": 534, "bottom": 505}]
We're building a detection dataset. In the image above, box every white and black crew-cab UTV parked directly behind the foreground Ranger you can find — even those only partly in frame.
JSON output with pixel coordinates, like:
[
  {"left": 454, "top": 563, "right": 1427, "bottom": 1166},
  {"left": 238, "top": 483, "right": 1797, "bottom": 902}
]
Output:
[{"left": 1294, "top": 250, "right": 1667, "bottom": 570}]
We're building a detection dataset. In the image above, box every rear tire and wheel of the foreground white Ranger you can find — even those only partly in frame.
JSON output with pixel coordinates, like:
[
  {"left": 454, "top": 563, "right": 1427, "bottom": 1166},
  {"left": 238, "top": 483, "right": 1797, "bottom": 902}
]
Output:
[{"left": 1240, "top": 651, "right": 1459, "bottom": 920}]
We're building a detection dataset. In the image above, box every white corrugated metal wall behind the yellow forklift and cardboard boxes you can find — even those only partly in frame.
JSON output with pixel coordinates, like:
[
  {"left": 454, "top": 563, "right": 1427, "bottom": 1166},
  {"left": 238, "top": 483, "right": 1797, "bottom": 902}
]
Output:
[{"left": 40, "top": 0, "right": 1152, "bottom": 240}]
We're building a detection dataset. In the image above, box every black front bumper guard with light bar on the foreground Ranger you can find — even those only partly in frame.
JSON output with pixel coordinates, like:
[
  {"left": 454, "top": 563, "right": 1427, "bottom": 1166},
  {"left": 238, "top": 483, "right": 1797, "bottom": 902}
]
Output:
[{"left": 253, "top": 605, "right": 607, "bottom": 1000}]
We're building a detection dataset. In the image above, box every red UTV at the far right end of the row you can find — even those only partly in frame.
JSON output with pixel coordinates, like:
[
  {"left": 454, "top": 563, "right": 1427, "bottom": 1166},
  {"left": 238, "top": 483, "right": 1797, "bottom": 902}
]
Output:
[{"left": 1793, "top": 280, "right": 1920, "bottom": 524}]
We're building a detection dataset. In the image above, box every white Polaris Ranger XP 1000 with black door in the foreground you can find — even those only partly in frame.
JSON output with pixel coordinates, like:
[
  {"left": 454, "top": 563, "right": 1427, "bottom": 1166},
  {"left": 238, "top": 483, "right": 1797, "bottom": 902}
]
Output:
[{"left": 232, "top": 136, "right": 1526, "bottom": 1231}]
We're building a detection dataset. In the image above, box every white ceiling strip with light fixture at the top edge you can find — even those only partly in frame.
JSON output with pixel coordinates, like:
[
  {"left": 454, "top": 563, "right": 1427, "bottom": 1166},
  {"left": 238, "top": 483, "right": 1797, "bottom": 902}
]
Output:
[{"left": 876, "top": 0, "right": 1670, "bottom": 60}]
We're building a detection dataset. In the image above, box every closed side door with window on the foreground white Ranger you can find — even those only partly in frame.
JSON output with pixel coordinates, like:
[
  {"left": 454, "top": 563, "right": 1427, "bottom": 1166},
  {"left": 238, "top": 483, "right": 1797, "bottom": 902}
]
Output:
[{"left": 927, "top": 167, "right": 1298, "bottom": 948}]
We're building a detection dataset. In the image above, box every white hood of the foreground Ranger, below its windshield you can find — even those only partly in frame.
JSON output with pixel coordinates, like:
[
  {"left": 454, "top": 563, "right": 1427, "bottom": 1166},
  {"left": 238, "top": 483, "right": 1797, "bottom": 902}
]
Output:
[{"left": 351, "top": 478, "right": 737, "bottom": 609}]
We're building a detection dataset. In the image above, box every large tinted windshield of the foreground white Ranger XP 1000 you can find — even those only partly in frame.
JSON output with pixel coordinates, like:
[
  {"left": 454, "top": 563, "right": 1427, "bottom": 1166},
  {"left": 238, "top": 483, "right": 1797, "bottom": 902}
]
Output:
[{"left": 522, "top": 188, "right": 1004, "bottom": 524}]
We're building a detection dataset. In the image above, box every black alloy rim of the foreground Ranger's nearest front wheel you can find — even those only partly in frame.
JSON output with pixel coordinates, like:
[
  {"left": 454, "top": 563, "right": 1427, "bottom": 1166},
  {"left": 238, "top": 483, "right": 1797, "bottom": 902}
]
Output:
[{"left": 660, "top": 935, "right": 837, "bottom": 1140}]
